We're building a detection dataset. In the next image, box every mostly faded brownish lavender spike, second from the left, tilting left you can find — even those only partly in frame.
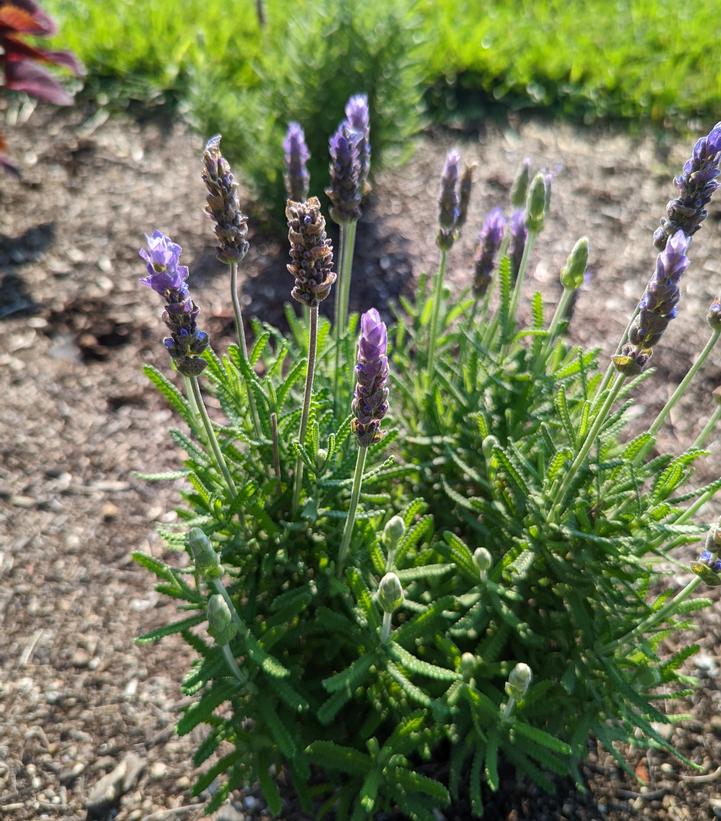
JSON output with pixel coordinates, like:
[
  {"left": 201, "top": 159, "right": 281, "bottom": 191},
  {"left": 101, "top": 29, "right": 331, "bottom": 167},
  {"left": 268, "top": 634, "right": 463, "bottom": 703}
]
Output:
[{"left": 202, "top": 134, "right": 248, "bottom": 264}]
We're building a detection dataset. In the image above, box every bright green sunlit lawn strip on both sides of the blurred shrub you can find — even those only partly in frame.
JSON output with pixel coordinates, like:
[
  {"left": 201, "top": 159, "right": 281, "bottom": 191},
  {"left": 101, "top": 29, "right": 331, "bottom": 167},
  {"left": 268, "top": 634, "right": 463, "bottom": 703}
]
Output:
[{"left": 47, "top": 0, "right": 721, "bottom": 123}]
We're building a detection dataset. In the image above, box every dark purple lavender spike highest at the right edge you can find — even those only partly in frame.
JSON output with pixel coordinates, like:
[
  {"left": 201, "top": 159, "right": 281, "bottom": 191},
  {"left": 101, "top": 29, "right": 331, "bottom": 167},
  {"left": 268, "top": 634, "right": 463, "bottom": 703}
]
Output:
[{"left": 653, "top": 122, "right": 721, "bottom": 251}]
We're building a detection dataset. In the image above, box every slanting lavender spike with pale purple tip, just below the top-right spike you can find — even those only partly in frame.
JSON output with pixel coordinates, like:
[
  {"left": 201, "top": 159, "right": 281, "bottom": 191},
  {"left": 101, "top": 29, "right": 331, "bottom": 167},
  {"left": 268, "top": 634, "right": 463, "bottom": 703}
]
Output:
[{"left": 614, "top": 230, "right": 691, "bottom": 373}]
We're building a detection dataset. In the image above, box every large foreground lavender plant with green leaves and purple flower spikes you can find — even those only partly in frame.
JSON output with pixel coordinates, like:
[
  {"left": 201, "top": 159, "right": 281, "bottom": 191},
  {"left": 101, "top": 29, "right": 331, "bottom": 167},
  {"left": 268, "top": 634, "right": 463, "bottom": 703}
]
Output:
[{"left": 135, "top": 112, "right": 721, "bottom": 821}]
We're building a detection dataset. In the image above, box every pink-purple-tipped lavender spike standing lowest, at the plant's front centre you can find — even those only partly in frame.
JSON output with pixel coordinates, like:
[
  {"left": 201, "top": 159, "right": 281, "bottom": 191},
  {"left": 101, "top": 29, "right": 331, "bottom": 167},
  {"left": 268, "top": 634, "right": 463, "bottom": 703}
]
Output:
[{"left": 352, "top": 308, "right": 388, "bottom": 447}]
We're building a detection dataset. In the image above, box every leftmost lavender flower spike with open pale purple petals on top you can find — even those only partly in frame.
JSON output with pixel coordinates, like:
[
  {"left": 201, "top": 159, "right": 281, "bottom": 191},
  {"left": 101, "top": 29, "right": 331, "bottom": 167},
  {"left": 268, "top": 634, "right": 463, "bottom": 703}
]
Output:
[{"left": 140, "top": 231, "right": 208, "bottom": 376}]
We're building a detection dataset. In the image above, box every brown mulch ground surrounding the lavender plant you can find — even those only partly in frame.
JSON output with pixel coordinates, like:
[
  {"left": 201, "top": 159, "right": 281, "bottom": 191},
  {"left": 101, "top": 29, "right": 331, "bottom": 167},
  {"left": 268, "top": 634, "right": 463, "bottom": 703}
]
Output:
[{"left": 0, "top": 108, "right": 721, "bottom": 821}]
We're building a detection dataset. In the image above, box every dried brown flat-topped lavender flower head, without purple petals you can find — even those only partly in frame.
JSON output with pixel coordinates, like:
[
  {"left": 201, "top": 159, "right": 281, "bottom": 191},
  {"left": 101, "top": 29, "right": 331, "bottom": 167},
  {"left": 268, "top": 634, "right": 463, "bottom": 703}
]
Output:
[{"left": 285, "top": 197, "right": 336, "bottom": 308}]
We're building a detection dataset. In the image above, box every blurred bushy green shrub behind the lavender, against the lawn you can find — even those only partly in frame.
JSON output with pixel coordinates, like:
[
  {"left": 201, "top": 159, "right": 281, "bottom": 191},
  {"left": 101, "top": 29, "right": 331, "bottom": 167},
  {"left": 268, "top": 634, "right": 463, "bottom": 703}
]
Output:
[{"left": 191, "top": 0, "right": 423, "bottom": 219}]
